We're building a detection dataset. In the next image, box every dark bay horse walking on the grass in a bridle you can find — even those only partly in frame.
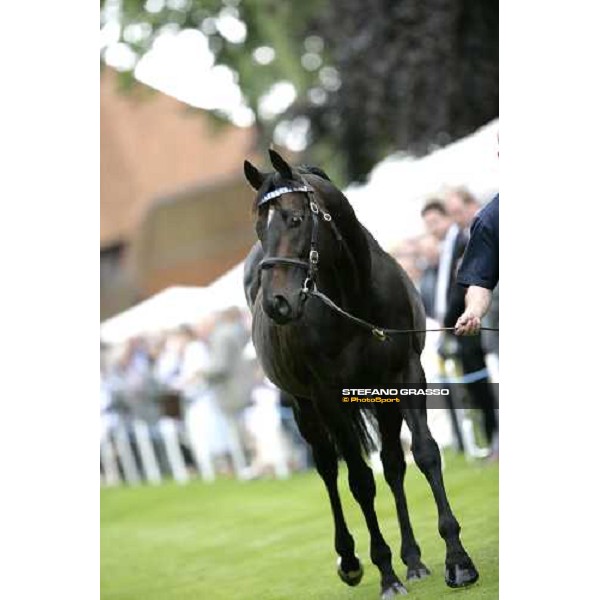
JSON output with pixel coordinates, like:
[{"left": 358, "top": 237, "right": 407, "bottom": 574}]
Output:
[{"left": 244, "top": 150, "right": 479, "bottom": 600}]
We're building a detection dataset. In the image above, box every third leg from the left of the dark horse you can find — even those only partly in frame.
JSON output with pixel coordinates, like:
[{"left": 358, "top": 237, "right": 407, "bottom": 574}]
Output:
[{"left": 377, "top": 405, "right": 429, "bottom": 581}]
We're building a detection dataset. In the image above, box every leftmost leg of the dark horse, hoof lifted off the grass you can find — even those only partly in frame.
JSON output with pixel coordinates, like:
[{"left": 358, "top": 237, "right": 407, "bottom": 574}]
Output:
[{"left": 294, "top": 400, "right": 363, "bottom": 586}]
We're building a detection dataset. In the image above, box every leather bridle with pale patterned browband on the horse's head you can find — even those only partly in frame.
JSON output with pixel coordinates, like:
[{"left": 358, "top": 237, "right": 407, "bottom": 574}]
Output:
[{"left": 258, "top": 179, "right": 342, "bottom": 296}]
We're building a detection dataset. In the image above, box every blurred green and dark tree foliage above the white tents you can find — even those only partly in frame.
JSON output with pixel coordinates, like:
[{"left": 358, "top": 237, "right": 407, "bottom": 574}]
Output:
[{"left": 101, "top": 0, "right": 498, "bottom": 183}]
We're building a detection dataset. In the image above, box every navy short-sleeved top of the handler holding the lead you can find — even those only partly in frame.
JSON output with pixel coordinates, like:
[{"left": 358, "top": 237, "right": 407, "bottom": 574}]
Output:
[{"left": 456, "top": 194, "right": 499, "bottom": 290}]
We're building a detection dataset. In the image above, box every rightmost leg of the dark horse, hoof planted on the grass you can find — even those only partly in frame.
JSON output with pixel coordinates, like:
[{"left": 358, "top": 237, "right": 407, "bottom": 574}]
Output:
[{"left": 404, "top": 360, "right": 479, "bottom": 588}]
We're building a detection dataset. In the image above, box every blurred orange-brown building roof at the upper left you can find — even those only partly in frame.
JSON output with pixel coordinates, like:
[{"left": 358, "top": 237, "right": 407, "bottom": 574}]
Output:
[{"left": 100, "top": 68, "right": 254, "bottom": 247}]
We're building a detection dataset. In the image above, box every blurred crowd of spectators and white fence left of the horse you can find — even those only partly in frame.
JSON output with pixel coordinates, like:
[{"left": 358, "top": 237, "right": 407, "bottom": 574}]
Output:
[{"left": 101, "top": 308, "right": 308, "bottom": 483}]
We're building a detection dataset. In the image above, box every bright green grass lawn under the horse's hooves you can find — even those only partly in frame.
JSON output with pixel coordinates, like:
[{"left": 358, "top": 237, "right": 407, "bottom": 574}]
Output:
[{"left": 101, "top": 454, "right": 498, "bottom": 600}]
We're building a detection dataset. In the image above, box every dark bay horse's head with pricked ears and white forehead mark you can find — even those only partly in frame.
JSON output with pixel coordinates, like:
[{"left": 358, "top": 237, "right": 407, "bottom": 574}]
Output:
[{"left": 244, "top": 150, "right": 328, "bottom": 325}]
